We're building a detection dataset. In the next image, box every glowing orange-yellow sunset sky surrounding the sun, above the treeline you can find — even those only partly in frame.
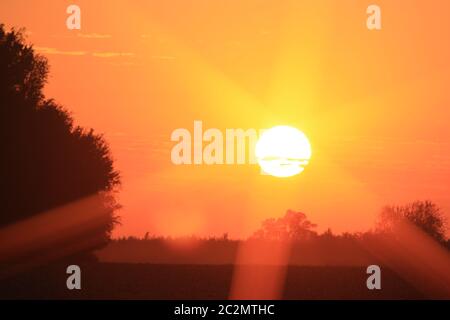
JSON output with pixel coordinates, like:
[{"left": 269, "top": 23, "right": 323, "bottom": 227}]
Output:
[{"left": 0, "top": 0, "right": 450, "bottom": 237}]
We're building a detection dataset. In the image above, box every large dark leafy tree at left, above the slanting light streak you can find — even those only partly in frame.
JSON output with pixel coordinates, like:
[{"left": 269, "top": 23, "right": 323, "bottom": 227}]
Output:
[{"left": 0, "top": 25, "right": 120, "bottom": 258}]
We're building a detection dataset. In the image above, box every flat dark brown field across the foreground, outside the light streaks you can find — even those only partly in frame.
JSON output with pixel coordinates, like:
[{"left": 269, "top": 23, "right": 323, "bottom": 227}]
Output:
[{"left": 0, "top": 263, "right": 424, "bottom": 299}]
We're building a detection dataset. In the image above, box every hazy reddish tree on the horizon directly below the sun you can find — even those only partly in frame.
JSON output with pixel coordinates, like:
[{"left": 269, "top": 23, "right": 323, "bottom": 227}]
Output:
[{"left": 253, "top": 210, "right": 317, "bottom": 240}]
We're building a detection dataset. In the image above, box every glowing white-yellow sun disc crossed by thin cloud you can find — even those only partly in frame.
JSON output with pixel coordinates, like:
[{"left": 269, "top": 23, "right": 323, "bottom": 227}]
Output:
[{"left": 255, "top": 126, "right": 311, "bottom": 178}]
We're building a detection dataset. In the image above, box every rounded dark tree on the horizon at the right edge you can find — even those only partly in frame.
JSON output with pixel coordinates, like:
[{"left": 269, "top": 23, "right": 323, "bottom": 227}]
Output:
[{"left": 377, "top": 201, "right": 446, "bottom": 242}]
